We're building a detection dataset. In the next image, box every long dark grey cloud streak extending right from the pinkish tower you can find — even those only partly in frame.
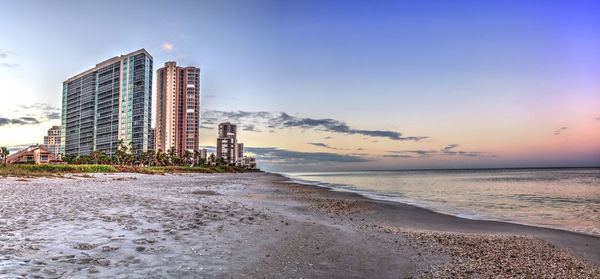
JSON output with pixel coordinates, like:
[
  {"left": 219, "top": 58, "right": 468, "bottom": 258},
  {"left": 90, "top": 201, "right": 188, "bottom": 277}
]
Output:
[{"left": 202, "top": 110, "right": 428, "bottom": 141}]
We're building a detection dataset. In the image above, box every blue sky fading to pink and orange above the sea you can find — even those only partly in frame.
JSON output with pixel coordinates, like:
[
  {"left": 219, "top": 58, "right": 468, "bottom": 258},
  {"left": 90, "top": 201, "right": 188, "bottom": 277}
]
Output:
[{"left": 0, "top": 1, "right": 600, "bottom": 170}]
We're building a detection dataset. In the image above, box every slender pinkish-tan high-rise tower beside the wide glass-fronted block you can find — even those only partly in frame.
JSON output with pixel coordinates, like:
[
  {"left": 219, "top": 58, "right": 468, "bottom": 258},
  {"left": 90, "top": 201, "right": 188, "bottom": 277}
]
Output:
[{"left": 155, "top": 62, "right": 200, "bottom": 156}]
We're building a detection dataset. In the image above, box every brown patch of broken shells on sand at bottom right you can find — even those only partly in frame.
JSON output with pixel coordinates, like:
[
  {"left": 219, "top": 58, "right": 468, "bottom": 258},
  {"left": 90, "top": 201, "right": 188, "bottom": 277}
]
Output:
[{"left": 375, "top": 228, "right": 600, "bottom": 279}]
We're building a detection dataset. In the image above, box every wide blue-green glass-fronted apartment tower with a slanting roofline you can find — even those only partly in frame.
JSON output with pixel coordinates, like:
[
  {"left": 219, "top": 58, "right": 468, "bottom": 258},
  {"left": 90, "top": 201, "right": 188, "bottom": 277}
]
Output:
[{"left": 61, "top": 49, "right": 152, "bottom": 155}]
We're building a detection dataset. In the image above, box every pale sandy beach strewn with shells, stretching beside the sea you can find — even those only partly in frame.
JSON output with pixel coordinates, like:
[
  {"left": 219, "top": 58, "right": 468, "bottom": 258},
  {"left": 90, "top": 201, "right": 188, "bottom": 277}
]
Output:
[{"left": 0, "top": 173, "right": 600, "bottom": 278}]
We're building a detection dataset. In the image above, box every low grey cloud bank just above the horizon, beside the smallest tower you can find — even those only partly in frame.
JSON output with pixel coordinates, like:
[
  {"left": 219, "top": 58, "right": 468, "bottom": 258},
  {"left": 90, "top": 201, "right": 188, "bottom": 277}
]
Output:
[{"left": 244, "top": 147, "right": 371, "bottom": 165}]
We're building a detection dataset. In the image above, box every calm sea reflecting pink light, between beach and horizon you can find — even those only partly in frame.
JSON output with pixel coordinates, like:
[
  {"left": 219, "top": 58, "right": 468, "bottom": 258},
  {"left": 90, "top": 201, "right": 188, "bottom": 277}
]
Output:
[{"left": 284, "top": 168, "right": 600, "bottom": 235}]
